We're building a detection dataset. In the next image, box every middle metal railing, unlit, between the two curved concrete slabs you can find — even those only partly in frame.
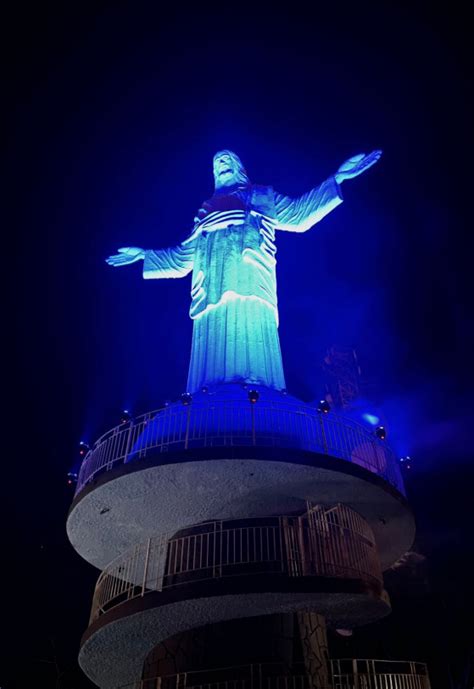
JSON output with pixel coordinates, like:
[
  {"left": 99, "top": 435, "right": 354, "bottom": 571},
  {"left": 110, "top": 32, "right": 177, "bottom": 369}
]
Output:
[{"left": 91, "top": 505, "right": 382, "bottom": 622}]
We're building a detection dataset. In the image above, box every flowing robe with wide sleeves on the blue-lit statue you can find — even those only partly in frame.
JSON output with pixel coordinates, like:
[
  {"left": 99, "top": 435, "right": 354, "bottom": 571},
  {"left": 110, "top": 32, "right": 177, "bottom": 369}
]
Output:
[{"left": 143, "top": 177, "right": 342, "bottom": 392}]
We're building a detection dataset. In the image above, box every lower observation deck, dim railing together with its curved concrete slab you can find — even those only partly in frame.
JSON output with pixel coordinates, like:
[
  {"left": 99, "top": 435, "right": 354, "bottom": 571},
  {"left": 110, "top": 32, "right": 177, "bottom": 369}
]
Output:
[{"left": 79, "top": 505, "right": 391, "bottom": 687}]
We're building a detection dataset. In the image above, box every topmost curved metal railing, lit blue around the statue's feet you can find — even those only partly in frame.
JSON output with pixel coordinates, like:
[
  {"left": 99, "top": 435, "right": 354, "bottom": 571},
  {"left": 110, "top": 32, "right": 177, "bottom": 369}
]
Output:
[{"left": 76, "top": 399, "right": 404, "bottom": 494}]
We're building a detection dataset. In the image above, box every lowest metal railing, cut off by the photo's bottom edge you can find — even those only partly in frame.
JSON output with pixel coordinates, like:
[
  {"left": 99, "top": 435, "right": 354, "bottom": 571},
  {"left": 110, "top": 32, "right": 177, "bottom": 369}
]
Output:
[{"left": 119, "top": 658, "right": 431, "bottom": 689}]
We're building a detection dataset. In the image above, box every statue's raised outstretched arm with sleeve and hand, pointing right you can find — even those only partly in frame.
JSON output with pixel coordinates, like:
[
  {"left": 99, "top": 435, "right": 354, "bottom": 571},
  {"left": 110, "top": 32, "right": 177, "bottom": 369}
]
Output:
[{"left": 275, "top": 151, "right": 382, "bottom": 232}]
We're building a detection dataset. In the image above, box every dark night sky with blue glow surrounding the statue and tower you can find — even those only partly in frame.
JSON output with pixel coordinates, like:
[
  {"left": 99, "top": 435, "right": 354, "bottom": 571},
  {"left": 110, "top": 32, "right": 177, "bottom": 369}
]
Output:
[{"left": 4, "top": 2, "right": 474, "bottom": 689}]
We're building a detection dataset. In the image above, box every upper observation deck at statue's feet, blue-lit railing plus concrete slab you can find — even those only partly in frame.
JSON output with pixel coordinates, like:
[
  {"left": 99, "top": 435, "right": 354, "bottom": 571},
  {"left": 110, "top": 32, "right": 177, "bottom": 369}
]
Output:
[{"left": 67, "top": 384, "right": 414, "bottom": 570}]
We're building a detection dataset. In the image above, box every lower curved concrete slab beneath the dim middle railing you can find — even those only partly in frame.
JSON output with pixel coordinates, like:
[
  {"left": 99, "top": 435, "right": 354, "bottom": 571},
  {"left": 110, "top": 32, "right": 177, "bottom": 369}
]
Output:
[{"left": 79, "top": 575, "right": 390, "bottom": 689}]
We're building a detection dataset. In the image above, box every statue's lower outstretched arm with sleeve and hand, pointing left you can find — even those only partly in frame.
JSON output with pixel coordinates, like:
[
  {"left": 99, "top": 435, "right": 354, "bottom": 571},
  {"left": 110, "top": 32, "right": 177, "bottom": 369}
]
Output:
[{"left": 106, "top": 242, "right": 194, "bottom": 280}]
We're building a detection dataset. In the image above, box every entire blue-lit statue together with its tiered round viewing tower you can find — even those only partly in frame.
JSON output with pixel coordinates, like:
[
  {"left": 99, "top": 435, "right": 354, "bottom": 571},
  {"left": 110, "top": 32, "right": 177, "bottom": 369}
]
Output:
[{"left": 67, "top": 151, "right": 429, "bottom": 689}]
